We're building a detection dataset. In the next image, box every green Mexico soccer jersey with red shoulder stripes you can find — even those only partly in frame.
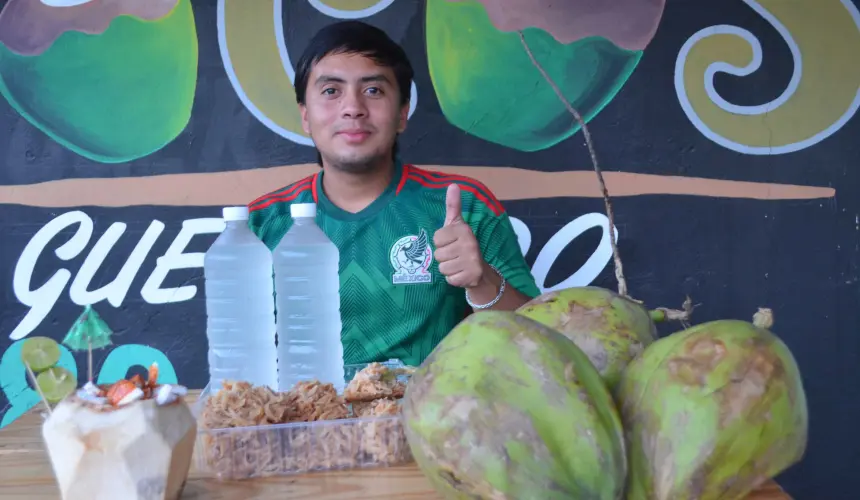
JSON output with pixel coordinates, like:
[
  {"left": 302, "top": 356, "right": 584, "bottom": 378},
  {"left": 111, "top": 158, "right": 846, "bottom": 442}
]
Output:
[{"left": 248, "top": 163, "right": 540, "bottom": 365}]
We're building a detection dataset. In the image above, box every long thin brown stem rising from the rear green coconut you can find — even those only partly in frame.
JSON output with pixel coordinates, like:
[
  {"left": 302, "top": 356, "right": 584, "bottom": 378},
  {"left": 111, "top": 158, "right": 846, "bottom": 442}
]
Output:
[{"left": 517, "top": 31, "right": 694, "bottom": 328}]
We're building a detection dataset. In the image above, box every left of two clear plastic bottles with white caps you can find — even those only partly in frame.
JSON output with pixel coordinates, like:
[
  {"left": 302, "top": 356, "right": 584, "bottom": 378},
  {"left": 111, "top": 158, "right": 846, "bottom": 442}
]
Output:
[{"left": 203, "top": 207, "right": 278, "bottom": 390}]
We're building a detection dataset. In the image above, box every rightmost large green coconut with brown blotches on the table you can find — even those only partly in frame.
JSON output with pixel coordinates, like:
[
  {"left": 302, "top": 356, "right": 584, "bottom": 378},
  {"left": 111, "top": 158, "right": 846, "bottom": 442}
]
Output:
[{"left": 616, "top": 309, "right": 808, "bottom": 500}]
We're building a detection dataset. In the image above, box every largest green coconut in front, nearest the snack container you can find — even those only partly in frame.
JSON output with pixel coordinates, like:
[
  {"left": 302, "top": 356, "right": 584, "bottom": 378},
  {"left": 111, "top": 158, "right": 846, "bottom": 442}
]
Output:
[{"left": 402, "top": 311, "right": 627, "bottom": 500}]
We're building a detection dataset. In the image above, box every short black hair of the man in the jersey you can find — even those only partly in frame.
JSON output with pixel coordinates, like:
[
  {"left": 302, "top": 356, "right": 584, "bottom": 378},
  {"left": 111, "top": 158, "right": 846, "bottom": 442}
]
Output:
[{"left": 293, "top": 20, "right": 415, "bottom": 165}]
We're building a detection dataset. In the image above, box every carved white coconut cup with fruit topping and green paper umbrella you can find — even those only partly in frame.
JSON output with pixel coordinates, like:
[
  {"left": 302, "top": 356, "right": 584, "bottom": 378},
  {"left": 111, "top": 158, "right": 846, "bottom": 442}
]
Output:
[{"left": 42, "top": 394, "right": 197, "bottom": 500}]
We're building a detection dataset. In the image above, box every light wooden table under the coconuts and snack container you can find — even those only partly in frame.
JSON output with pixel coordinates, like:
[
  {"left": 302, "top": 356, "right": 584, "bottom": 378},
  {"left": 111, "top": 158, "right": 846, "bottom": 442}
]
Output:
[{"left": 0, "top": 391, "right": 791, "bottom": 500}]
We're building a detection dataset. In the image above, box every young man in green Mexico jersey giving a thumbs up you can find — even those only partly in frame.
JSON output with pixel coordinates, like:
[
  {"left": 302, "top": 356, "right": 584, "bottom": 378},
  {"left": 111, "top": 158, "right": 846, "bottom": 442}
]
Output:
[{"left": 249, "top": 21, "right": 539, "bottom": 365}]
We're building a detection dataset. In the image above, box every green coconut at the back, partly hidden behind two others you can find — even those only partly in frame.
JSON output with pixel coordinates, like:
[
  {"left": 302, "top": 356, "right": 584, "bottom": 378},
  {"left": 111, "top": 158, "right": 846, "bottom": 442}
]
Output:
[{"left": 517, "top": 286, "right": 657, "bottom": 389}]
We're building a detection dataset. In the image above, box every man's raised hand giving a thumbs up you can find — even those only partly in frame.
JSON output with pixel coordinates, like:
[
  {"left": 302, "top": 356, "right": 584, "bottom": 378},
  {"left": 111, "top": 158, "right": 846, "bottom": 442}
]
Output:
[{"left": 433, "top": 183, "right": 487, "bottom": 289}]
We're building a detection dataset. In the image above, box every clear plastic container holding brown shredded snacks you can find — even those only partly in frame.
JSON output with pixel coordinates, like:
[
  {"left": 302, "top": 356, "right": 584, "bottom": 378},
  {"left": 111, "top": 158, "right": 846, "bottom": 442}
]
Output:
[{"left": 192, "top": 360, "right": 414, "bottom": 480}]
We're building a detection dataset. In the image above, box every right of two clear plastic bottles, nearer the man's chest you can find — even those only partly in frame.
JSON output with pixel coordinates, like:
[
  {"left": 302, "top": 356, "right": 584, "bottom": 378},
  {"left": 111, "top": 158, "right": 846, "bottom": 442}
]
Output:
[{"left": 273, "top": 203, "right": 345, "bottom": 393}]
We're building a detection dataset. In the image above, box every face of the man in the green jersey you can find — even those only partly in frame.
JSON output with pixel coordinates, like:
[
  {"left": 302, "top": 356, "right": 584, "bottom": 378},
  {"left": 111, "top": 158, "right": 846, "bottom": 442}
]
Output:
[{"left": 300, "top": 50, "right": 409, "bottom": 173}]
